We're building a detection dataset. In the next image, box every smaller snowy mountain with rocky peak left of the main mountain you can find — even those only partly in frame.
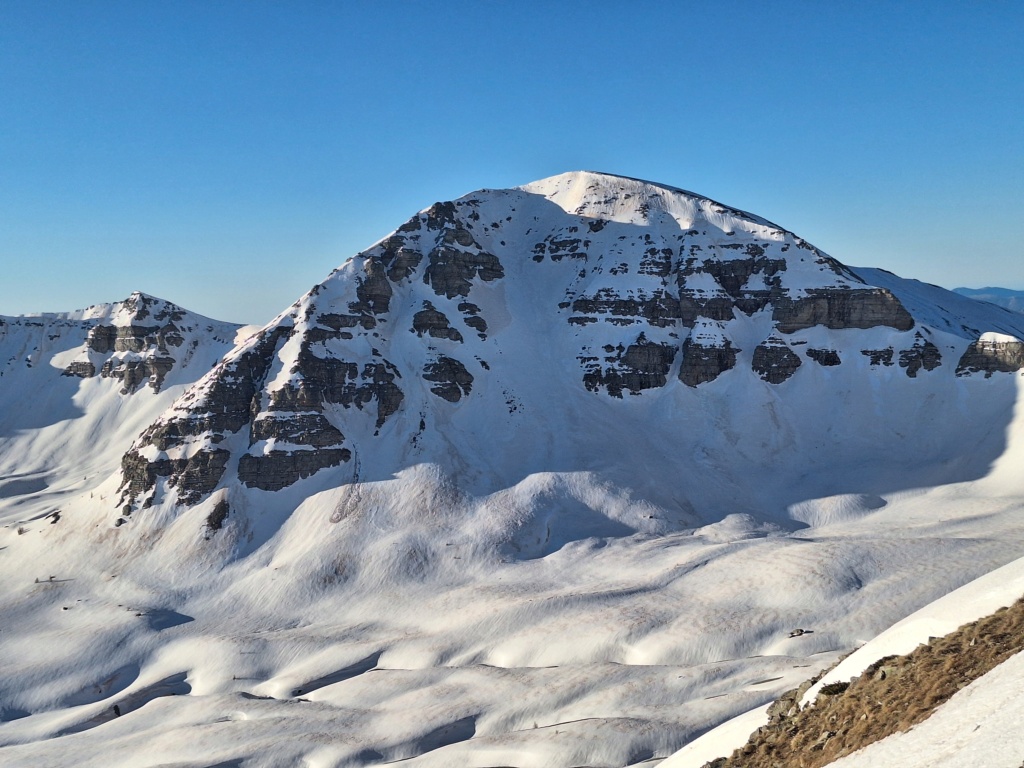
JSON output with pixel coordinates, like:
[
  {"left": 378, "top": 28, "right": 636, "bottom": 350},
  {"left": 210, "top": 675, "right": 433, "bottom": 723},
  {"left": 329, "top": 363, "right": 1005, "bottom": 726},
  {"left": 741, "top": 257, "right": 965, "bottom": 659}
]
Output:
[{"left": 0, "top": 293, "right": 241, "bottom": 524}]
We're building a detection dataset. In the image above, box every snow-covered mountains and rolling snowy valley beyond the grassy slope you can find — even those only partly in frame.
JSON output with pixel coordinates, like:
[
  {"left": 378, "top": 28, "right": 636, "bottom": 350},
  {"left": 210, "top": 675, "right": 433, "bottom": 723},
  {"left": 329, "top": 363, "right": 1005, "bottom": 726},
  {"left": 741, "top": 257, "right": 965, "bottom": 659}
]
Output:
[{"left": 0, "top": 172, "right": 1024, "bottom": 768}]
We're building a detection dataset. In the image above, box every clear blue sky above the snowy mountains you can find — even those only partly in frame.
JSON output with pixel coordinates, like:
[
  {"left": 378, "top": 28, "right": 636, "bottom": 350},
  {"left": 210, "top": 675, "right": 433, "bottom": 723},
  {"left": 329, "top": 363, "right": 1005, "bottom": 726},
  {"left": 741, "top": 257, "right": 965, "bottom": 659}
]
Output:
[{"left": 0, "top": 0, "right": 1024, "bottom": 323}]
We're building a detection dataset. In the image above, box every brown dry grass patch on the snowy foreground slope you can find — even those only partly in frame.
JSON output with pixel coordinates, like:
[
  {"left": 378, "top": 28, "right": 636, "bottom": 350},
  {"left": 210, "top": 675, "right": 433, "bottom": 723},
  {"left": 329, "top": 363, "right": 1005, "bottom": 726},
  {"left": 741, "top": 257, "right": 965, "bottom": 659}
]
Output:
[{"left": 706, "top": 598, "right": 1024, "bottom": 768}]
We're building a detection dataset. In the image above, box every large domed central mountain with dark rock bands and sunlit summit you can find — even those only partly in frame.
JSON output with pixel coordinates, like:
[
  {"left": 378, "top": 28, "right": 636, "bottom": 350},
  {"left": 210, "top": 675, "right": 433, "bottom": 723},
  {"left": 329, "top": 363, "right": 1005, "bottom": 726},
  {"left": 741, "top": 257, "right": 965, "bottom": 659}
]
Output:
[{"left": 110, "top": 172, "right": 1024, "bottom": 551}]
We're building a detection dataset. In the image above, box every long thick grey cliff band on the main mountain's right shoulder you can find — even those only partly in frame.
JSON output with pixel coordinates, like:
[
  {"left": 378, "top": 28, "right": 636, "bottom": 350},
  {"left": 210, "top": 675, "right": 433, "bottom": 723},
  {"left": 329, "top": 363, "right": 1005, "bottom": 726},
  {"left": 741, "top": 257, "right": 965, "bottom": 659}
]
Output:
[{"left": 772, "top": 288, "right": 913, "bottom": 334}]
